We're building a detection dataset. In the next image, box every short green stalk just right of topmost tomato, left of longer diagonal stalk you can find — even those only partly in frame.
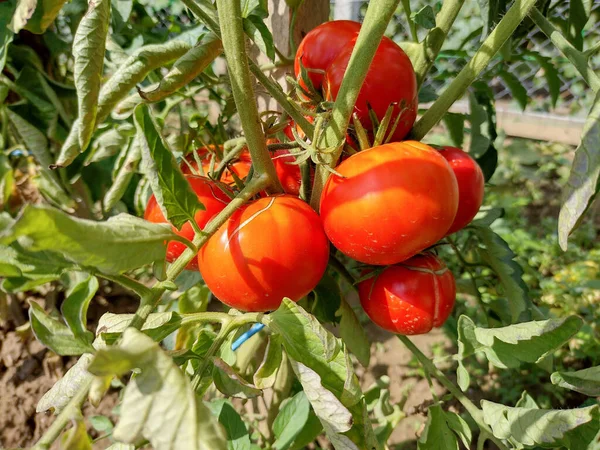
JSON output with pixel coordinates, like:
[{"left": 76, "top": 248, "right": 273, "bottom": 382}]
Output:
[{"left": 410, "top": 0, "right": 465, "bottom": 86}]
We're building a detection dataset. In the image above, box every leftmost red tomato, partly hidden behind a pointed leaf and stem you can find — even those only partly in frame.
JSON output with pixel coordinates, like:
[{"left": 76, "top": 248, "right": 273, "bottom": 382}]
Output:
[{"left": 144, "top": 175, "right": 230, "bottom": 270}]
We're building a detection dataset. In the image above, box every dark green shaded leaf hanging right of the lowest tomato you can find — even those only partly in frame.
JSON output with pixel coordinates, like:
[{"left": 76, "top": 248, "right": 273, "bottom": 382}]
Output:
[{"left": 473, "top": 226, "right": 532, "bottom": 323}]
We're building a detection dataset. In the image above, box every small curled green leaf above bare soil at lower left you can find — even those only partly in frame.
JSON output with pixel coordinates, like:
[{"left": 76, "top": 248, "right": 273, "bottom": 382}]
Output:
[{"left": 29, "top": 301, "right": 94, "bottom": 356}]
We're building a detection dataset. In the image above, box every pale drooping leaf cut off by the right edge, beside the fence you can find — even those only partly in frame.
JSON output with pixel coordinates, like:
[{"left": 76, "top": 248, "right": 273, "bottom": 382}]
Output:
[{"left": 558, "top": 93, "right": 600, "bottom": 250}]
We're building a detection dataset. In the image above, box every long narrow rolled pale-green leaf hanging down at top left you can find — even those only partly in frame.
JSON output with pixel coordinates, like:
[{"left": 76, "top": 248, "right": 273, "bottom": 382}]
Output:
[{"left": 72, "top": 0, "right": 110, "bottom": 151}]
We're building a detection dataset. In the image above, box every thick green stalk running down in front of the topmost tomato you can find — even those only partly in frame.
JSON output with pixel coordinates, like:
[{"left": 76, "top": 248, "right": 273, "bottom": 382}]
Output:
[{"left": 310, "top": 0, "right": 400, "bottom": 211}]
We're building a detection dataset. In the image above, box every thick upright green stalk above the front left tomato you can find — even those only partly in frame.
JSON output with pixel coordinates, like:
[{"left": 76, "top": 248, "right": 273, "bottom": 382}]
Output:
[{"left": 217, "top": 0, "right": 283, "bottom": 193}]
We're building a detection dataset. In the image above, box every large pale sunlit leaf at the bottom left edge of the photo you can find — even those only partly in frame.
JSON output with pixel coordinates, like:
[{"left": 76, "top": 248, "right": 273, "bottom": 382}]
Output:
[{"left": 89, "top": 328, "right": 227, "bottom": 450}]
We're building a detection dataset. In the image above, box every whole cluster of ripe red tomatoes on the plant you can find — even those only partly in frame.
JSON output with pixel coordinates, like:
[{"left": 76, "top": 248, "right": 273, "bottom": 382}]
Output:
[{"left": 145, "top": 21, "right": 484, "bottom": 334}]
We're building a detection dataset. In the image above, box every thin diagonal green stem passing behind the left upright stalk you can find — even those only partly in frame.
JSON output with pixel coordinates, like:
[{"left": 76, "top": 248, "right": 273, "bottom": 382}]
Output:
[{"left": 182, "top": 0, "right": 314, "bottom": 136}]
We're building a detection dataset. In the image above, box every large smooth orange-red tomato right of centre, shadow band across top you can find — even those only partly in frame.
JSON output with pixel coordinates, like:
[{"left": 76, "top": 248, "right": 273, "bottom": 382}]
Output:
[{"left": 320, "top": 141, "right": 458, "bottom": 265}]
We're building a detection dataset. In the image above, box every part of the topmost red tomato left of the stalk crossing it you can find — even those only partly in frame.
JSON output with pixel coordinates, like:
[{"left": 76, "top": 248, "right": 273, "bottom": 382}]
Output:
[{"left": 294, "top": 20, "right": 360, "bottom": 91}]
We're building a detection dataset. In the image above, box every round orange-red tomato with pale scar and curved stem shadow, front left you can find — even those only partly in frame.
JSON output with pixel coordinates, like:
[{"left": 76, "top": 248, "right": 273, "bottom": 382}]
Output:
[{"left": 198, "top": 195, "right": 329, "bottom": 311}]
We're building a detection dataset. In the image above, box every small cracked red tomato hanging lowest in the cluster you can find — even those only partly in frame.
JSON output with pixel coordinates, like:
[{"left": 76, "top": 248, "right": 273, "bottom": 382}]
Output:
[{"left": 358, "top": 254, "right": 456, "bottom": 335}]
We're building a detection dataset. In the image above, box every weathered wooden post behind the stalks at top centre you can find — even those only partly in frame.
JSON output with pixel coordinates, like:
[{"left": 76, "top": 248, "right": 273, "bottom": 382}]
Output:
[{"left": 251, "top": 0, "right": 329, "bottom": 111}]
